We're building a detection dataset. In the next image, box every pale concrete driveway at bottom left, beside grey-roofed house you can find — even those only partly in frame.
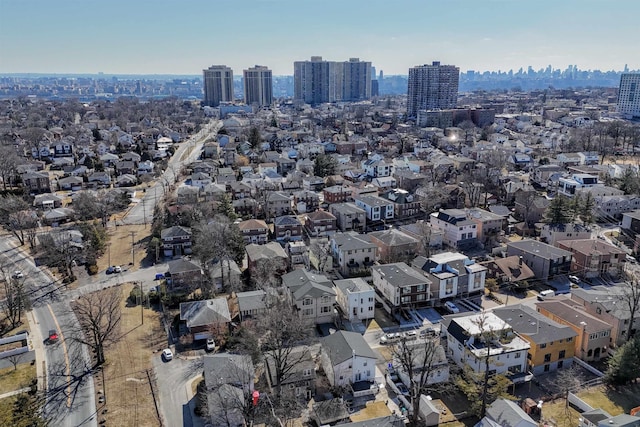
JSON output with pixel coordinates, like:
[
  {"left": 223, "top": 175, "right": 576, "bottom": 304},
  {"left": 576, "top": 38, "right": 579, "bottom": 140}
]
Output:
[{"left": 153, "top": 353, "right": 205, "bottom": 427}]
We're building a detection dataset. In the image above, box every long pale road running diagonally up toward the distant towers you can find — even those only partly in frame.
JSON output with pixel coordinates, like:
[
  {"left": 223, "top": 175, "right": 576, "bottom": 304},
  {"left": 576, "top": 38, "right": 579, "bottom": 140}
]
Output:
[{"left": 122, "top": 120, "right": 222, "bottom": 224}]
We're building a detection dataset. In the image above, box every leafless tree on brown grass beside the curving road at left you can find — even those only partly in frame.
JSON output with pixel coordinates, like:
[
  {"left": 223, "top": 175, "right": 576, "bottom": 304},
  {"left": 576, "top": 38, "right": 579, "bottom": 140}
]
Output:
[{"left": 72, "top": 288, "right": 122, "bottom": 366}]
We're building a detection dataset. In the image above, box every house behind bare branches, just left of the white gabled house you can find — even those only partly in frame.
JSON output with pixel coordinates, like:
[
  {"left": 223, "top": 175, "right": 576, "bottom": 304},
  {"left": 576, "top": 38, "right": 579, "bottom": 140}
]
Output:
[{"left": 264, "top": 347, "right": 316, "bottom": 401}]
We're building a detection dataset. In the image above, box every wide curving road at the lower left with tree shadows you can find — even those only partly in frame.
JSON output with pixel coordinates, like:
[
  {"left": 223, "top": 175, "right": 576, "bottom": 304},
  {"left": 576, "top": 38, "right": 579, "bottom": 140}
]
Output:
[{"left": 0, "top": 235, "right": 97, "bottom": 427}]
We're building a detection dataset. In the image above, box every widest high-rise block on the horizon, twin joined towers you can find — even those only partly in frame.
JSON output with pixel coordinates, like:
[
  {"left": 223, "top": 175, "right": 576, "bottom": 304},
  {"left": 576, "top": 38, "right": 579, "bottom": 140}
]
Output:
[{"left": 293, "top": 56, "right": 371, "bottom": 105}]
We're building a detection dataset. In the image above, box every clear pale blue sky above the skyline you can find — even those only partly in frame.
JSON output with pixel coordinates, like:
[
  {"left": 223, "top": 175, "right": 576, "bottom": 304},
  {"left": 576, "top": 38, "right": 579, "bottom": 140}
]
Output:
[{"left": 0, "top": 0, "right": 640, "bottom": 75}]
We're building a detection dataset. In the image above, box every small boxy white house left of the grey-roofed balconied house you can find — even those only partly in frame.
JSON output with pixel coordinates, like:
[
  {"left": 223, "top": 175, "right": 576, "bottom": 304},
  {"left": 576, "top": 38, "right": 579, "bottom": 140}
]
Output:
[{"left": 333, "top": 277, "right": 376, "bottom": 322}]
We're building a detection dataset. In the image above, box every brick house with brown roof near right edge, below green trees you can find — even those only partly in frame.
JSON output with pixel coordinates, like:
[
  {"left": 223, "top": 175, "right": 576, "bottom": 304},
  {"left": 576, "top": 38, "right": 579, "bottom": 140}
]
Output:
[{"left": 556, "top": 239, "right": 627, "bottom": 278}]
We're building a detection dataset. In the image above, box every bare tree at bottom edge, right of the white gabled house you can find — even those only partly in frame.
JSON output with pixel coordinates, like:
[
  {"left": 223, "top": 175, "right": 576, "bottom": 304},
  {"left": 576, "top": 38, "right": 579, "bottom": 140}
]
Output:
[{"left": 391, "top": 336, "right": 447, "bottom": 426}]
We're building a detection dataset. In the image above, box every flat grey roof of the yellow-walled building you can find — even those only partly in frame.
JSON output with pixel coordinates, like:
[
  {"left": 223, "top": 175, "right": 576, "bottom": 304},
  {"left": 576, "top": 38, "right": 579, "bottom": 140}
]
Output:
[{"left": 493, "top": 304, "right": 578, "bottom": 344}]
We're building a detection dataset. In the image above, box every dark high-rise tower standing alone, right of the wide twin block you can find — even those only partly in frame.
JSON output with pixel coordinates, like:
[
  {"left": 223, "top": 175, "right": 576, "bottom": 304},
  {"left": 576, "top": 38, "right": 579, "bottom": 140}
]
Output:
[{"left": 407, "top": 61, "right": 460, "bottom": 118}]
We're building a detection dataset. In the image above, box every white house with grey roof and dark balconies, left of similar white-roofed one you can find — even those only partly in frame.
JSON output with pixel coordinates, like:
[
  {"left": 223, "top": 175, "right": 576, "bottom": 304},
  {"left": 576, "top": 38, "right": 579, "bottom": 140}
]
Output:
[{"left": 371, "top": 262, "right": 432, "bottom": 314}]
